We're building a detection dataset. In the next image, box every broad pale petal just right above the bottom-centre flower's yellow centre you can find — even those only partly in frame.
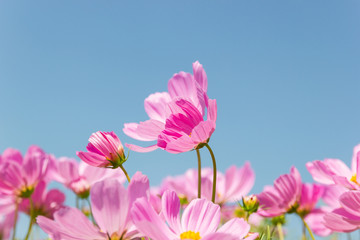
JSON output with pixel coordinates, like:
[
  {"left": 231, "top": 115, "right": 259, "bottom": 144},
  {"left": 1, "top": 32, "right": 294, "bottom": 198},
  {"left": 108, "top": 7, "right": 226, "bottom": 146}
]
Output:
[{"left": 181, "top": 199, "right": 220, "bottom": 236}]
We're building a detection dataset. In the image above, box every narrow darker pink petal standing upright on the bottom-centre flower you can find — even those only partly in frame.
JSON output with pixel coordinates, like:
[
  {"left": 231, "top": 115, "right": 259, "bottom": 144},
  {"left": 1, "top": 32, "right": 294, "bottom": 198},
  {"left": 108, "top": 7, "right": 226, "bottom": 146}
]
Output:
[{"left": 161, "top": 190, "right": 181, "bottom": 232}]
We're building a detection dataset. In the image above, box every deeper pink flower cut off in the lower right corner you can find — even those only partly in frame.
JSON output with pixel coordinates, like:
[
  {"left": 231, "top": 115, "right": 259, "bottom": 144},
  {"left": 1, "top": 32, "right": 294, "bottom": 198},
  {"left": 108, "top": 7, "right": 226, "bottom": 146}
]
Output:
[{"left": 324, "top": 191, "right": 360, "bottom": 232}]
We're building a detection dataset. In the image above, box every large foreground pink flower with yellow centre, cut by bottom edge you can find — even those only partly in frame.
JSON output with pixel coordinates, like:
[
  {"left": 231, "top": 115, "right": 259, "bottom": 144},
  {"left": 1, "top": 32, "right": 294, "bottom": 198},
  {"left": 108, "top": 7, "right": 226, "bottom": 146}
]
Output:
[{"left": 131, "top": 191, "right": 258, "bottom": 240}]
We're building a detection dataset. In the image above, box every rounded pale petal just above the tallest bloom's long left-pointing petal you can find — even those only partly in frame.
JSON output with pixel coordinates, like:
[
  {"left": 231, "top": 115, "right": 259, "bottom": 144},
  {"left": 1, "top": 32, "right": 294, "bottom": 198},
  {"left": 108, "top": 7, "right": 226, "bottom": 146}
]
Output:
[{"left": 144, "top": 92, "right": 171, "bottom": 122}]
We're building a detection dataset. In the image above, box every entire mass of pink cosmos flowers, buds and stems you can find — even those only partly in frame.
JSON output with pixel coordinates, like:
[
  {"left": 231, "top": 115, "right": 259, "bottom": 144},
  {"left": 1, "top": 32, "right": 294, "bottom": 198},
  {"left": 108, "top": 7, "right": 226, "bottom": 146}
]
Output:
[{"left": 0, "top": 62, "right": 360, "bottom": 240}]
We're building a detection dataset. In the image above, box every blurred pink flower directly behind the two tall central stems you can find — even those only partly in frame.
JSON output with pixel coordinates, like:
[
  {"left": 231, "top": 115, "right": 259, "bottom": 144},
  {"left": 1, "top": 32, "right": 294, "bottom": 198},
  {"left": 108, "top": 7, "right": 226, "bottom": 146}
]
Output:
[{"left": 162, "top": 162, "right": 255, "bottom": 205}]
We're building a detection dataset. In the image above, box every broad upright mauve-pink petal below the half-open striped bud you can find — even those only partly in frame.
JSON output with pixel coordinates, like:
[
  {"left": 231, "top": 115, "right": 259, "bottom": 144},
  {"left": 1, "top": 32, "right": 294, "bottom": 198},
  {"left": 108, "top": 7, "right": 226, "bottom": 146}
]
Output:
[{"left": 91, "top": 179, "right": 129, "bottom": 236}]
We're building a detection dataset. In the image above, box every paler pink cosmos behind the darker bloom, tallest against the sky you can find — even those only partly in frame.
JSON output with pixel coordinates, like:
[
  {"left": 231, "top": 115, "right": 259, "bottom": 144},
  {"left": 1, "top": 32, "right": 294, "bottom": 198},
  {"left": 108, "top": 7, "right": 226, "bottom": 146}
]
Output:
[{"left": 123, "top": 61, "right": 208, "bottom": 152}]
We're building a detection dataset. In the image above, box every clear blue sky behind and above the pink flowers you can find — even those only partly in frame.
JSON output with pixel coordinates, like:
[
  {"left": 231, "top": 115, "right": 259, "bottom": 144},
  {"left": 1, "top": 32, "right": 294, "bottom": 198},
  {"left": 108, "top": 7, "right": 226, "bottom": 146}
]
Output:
[{"left": 0, "top": 0, "right": 360, "bottom": 238}]
